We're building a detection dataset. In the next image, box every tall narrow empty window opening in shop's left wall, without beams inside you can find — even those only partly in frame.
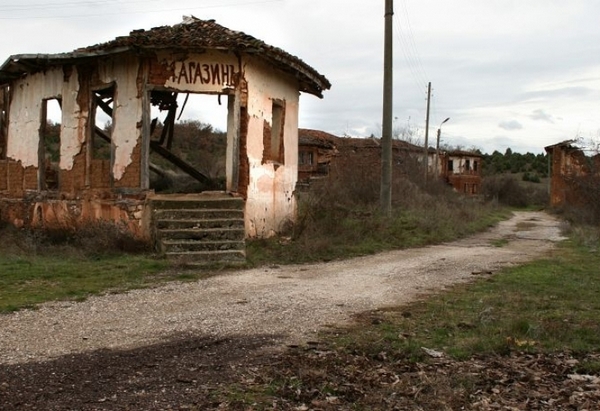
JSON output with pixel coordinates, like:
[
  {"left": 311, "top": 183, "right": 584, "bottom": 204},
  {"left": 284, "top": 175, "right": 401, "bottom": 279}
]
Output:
[{"left": 38, "top": 98, "right": 62, "bottom": 190}]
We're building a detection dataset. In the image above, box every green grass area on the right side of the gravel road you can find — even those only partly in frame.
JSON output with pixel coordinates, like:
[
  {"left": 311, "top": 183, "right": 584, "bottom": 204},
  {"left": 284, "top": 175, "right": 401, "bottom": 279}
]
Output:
[{"left": 337, "top": 237, "right": 600, "bottom": 362}]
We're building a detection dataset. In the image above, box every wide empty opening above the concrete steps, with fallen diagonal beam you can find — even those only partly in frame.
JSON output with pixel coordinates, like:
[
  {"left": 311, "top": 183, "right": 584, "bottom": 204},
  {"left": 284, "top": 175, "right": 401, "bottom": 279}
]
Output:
[{"left": 150, "top": 90, "right": 228, "bottom": 193}]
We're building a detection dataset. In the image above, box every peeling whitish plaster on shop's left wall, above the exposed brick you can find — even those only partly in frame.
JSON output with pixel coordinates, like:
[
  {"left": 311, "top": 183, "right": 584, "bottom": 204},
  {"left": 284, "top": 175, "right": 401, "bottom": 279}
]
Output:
[{"left": 7, "top": 56, "right": 142, "bottom": 181}]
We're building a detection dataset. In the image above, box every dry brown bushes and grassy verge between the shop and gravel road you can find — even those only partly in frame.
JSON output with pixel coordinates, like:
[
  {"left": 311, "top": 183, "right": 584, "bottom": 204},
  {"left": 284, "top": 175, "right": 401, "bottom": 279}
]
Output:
[{"left": 248, "top": 156, "right": 500, "bottom": 264}]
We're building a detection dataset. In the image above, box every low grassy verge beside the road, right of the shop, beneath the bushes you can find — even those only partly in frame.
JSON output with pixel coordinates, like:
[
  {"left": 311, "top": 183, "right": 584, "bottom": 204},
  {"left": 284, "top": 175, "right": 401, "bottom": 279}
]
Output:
[{"left": 246, "top": 201, "right": 510, "bottom": 266}]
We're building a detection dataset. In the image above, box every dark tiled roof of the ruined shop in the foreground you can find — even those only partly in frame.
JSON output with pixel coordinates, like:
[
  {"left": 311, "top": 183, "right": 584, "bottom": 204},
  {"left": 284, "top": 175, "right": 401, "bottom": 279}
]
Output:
[{"left": 0, "top": 17, "right": 331, "bottom": 97}]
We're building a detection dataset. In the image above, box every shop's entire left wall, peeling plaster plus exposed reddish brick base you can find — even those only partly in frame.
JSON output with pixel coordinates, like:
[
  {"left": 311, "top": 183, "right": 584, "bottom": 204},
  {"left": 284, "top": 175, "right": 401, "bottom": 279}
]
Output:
[{"left": 0, "top": 56, "right": 145, "bottom": 236}]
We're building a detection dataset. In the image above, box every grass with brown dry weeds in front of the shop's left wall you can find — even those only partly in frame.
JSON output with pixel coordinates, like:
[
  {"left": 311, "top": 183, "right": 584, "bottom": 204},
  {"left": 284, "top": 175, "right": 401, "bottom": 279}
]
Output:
[{"left": 0, "top": 221, "right": 231, "bottom": 313}]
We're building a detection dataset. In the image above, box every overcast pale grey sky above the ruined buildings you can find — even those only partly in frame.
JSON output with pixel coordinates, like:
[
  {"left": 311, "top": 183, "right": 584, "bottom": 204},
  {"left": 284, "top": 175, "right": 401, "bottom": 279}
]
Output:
[{"left": 0, "top": 0, "right": 600, "bottom": 153}]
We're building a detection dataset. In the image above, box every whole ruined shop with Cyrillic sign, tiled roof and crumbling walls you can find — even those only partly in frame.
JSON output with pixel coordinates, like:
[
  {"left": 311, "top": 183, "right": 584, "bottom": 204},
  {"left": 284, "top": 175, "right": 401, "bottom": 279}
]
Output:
[{"left": 0, "top": 17, "right": 330, "bottom": 264}]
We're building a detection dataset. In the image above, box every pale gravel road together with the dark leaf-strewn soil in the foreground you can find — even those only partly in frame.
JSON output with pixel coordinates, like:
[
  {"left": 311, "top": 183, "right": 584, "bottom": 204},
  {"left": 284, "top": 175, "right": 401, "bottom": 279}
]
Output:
[{"left": 0, "top": 213, "right": 600, "bottom": 410}]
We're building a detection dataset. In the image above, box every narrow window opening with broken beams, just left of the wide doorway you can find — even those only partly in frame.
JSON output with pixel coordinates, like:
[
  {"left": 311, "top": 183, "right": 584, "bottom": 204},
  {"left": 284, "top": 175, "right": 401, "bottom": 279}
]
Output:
[{"left": 91, "top": 84, "right": 115, "bottom": 161}]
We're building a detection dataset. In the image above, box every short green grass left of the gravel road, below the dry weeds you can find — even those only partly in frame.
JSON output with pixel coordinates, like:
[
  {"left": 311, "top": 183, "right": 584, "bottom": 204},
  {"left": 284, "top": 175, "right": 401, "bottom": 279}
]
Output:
[{"left": 0, "top": 255, "right": 172, "bottom": 313}]
